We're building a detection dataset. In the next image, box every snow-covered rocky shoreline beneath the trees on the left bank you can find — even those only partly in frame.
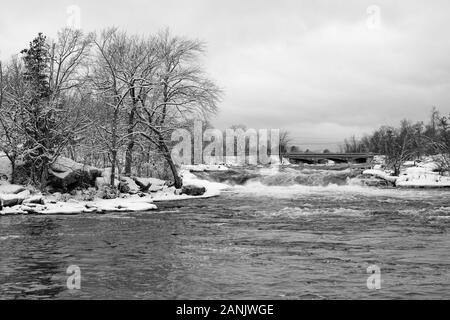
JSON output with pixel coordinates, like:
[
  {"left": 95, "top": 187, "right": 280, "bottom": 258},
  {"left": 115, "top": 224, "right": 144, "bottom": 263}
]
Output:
[{"left": 0, "top": 166, "right": 228, "bottom": 215}]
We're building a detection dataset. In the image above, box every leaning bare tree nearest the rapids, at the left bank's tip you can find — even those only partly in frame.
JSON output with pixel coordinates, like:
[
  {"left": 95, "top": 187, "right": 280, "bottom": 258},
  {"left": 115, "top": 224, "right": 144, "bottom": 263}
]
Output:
[{"left": 138, "top": 30, "right": 220, "bottom": 188}]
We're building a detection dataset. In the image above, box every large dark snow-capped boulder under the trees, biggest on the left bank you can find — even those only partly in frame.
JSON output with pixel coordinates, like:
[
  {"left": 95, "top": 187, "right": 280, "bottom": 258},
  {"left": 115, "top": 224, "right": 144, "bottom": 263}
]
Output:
[{"left": 48, "top": 157, "right": 102, "bottom": 192}]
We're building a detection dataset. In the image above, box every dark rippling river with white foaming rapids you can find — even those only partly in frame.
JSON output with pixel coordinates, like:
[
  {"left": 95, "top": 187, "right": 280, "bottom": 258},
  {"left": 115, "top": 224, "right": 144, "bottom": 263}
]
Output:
[{"left": 0, "top": 169, "right": 450, "bottom": 299}]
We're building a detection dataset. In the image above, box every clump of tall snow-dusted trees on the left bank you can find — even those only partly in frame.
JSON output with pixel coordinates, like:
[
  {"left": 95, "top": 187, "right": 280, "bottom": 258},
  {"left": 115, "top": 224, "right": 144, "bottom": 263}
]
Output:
[{"left": 0, "top": 28, "right": 221, "bottom": 190}]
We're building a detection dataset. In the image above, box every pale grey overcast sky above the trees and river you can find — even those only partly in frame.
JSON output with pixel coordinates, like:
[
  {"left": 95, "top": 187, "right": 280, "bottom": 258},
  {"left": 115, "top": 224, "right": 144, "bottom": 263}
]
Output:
[{"left": 0, "top": 0, "right": 450, "bottom": 150}]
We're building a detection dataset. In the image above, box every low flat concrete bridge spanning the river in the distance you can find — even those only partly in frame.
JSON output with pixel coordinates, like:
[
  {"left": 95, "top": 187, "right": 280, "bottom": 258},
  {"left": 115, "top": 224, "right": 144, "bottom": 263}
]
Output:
[{"left": 285, "top": 152, "right": 375, "bottom": 163}]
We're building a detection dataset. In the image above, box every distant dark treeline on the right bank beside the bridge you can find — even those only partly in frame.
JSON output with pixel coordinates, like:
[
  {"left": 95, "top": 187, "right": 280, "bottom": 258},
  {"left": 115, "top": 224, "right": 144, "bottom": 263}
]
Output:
[{"left": 341, "top": 107, "right": 450, "bottom": 174}]
